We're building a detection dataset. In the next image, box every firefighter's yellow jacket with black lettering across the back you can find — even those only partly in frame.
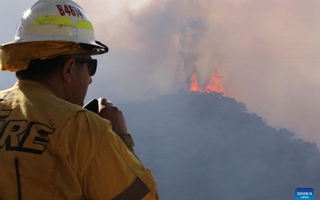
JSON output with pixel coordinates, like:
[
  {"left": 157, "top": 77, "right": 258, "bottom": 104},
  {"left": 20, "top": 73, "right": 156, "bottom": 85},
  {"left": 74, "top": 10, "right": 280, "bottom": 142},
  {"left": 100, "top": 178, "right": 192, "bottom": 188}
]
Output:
[{"left": 0, "top": 81, "right": 159, "bottom": 200}]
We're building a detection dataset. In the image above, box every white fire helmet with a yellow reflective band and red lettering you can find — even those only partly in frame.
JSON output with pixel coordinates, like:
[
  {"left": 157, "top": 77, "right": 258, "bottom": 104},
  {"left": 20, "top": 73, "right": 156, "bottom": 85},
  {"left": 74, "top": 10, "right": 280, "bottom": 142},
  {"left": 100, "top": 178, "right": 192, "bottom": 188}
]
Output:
[{"left": 0, "top": 0, "right": 108, "bottom": 55}]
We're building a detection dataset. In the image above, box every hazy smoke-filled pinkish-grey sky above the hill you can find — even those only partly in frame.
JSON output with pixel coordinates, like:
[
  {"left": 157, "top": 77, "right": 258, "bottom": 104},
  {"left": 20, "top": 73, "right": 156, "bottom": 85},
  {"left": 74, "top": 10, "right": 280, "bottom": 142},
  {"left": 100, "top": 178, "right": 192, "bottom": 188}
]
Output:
[{"left": 0, "top": 0, "right": 320, "bottom": 145}]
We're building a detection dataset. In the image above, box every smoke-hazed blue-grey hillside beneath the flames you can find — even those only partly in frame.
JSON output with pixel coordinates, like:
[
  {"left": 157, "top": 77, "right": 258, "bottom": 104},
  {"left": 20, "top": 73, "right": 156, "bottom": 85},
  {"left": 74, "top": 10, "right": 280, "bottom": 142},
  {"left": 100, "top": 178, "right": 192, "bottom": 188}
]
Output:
[{"left": 118, "top": 92, "right": 320, "bottom": 200}]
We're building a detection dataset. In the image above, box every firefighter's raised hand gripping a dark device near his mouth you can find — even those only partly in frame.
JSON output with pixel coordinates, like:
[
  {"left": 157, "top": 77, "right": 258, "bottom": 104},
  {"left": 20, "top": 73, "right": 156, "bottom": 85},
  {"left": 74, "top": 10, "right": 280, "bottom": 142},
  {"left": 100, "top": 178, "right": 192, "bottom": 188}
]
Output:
[{"left": 98, "top": 98, "right": 127, "bottom": 133}]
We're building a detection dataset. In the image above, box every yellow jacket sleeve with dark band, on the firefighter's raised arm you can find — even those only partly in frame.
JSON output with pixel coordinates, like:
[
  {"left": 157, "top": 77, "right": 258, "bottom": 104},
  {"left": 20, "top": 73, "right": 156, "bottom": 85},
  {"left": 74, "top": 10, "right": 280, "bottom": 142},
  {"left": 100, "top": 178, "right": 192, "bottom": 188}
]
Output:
[{"left": 64, "top": 112, "right": 159, "bottom": 200}]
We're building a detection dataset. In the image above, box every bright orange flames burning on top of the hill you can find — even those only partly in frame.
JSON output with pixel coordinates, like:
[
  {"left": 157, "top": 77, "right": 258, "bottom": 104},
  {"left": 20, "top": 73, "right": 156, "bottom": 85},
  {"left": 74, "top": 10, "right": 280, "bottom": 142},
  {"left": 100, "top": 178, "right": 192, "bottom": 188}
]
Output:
[{"left": 190, "top": 71, "right": 226, "bottom": 96}]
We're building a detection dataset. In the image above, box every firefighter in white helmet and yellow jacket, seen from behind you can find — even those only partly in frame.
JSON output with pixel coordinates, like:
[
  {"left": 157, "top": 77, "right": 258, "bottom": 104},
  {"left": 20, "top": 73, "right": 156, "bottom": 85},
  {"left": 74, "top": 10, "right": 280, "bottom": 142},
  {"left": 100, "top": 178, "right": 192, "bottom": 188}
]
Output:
[{"left": 0, "top": 0, "right": 159, "bottom": 200}]
